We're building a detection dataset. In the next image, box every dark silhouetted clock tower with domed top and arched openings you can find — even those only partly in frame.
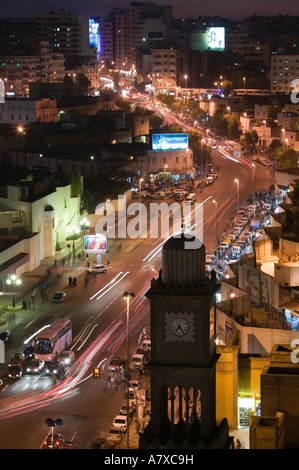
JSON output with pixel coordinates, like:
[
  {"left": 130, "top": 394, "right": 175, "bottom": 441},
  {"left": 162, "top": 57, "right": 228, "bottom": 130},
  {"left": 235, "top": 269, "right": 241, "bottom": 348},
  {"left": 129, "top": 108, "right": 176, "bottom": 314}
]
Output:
[{"left": 139, "top": 233, "right": 228, "bottom": 448}]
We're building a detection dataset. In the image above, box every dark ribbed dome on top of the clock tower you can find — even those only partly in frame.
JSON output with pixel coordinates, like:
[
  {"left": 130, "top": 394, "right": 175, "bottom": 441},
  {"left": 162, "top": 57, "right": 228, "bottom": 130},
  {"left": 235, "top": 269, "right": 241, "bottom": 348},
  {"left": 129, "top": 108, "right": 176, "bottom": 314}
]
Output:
[{"left": 162, "top": 233, "right": 206, "bottom": 288}]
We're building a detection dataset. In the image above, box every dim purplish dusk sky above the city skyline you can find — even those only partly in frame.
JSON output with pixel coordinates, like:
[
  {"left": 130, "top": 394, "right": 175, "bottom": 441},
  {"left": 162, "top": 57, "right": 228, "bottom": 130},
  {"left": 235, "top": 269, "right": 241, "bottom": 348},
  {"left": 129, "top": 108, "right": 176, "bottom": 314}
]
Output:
[{"left": 0, "top": 0, "right": 299, "bottom": 19}]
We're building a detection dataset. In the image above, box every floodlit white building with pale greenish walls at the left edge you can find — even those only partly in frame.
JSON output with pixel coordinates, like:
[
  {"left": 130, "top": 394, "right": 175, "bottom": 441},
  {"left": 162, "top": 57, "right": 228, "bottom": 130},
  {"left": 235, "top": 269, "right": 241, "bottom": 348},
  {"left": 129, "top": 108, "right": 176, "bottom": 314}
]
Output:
[{"left": 0, "top": 177, "right": 80, "bottom": 283}]
